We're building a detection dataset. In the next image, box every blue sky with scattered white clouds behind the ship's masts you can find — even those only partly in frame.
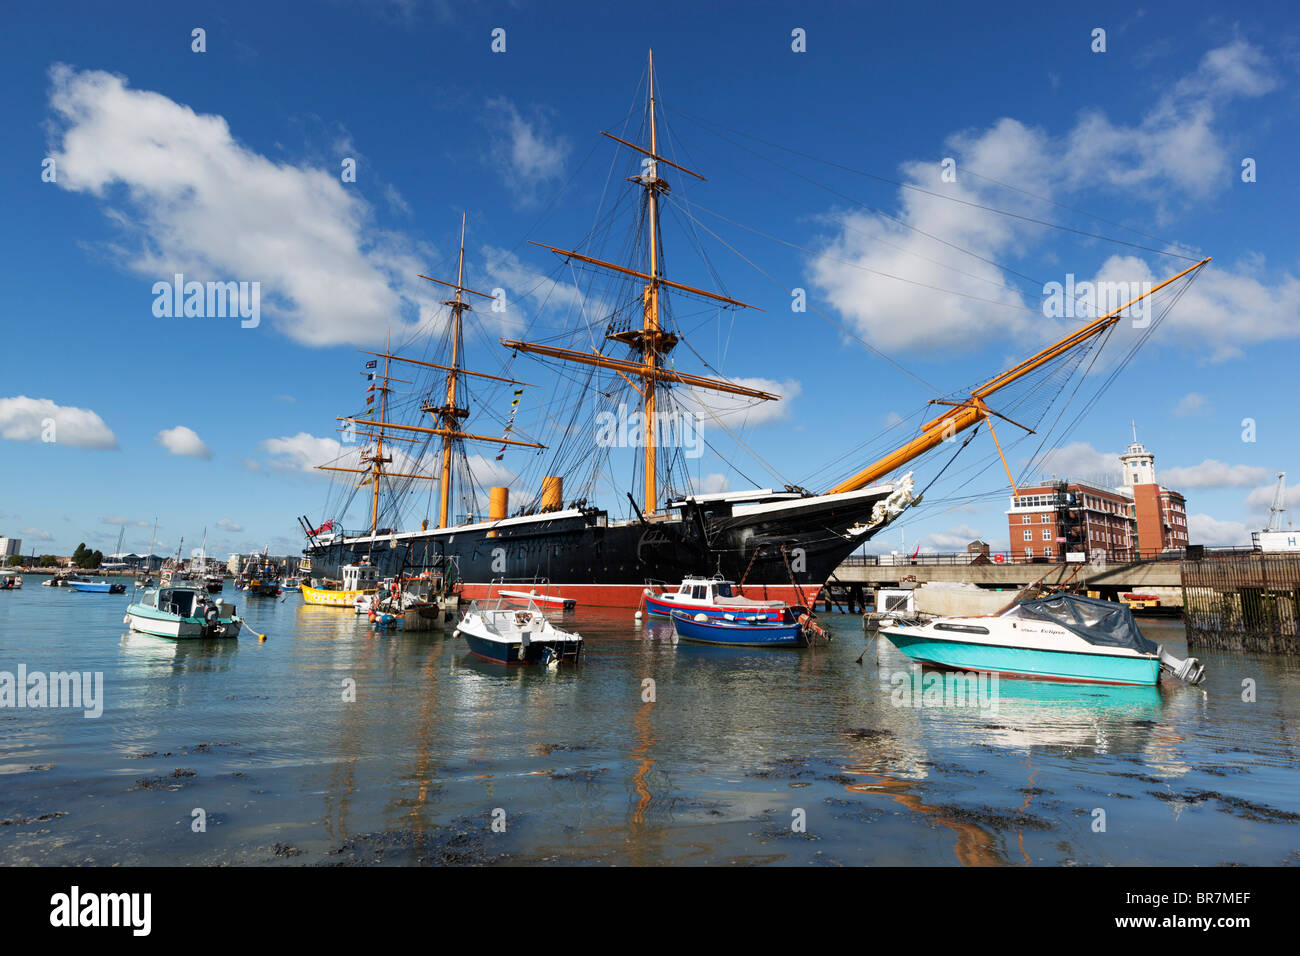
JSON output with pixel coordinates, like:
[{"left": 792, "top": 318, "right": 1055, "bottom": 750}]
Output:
[{"left": 0, "top": 0, "right": 1300, "bottom": 554}]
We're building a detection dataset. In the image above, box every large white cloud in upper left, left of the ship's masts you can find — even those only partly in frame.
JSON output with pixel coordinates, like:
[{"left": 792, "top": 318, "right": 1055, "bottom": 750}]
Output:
[{"left": 49, "top": 65, "right": 437, "bottom": 346}]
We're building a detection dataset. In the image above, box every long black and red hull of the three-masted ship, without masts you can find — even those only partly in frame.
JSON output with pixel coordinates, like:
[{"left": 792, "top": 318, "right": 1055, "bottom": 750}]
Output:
[{"left": 304, "top": 481, "right": 910, "bottom": 607}]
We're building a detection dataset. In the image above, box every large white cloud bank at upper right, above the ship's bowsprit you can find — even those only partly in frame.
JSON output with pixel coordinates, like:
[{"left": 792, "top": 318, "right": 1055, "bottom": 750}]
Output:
[{"left": 809, "top": 40, "right": 1300, "bottom": 359}]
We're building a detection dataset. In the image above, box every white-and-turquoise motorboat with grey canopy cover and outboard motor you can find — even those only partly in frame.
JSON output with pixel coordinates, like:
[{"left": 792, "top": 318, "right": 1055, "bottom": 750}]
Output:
[{"left": 880, "top": 593, "right": 1205, "bottom": 685}]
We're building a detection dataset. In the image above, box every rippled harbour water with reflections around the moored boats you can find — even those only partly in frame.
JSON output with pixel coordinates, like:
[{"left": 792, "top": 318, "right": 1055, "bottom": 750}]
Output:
[{"left": 0, "top": 575, "right": 1300, "bottom": 866}]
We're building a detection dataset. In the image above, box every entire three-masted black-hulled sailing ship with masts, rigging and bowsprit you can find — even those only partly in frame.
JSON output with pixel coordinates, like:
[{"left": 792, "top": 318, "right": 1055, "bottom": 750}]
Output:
[{"left": 299, "top": 56, "right": 1209, "bottom": 607}]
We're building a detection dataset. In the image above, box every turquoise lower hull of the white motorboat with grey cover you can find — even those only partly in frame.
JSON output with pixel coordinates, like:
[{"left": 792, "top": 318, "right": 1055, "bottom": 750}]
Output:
[{"left": 880, "top": 630, "right": 1160, "bottom": 685}]
